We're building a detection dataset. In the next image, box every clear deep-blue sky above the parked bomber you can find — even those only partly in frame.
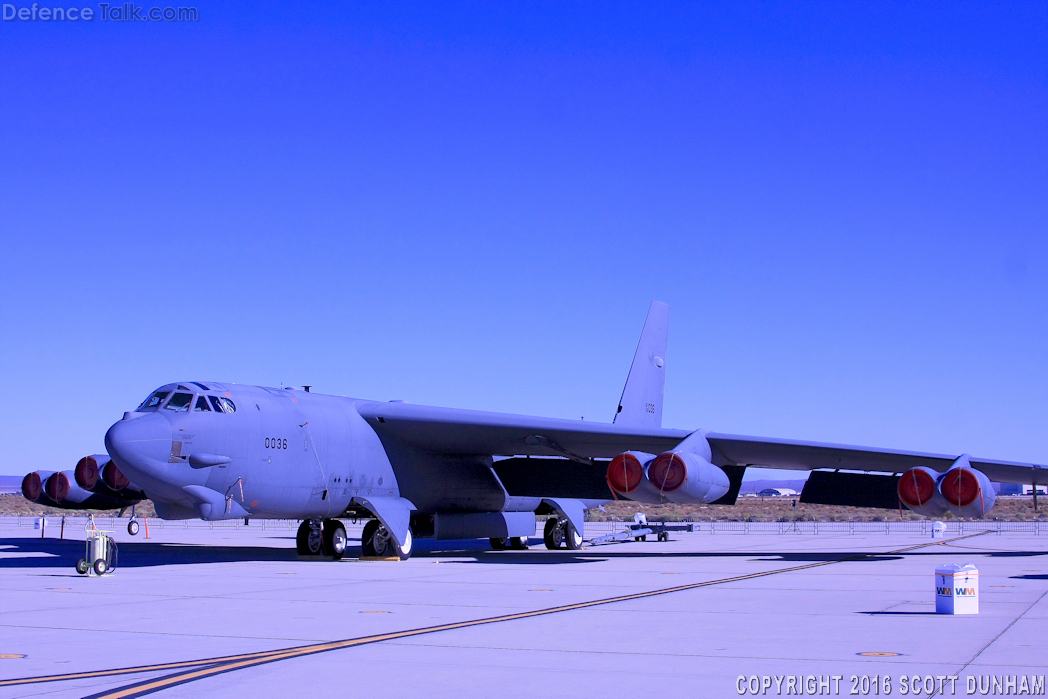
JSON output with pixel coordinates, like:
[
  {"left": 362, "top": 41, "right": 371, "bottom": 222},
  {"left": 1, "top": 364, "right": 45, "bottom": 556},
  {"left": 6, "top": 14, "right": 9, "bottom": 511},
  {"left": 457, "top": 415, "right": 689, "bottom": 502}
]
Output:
[{"left": 0, "top": 2, "right": 1048, "bottom": 482}]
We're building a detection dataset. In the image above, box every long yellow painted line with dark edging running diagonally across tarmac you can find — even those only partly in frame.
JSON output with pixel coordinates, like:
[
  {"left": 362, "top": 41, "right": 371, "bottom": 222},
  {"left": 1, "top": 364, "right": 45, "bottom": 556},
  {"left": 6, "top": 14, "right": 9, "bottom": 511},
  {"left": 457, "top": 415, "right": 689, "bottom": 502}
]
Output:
[{"left": 0, "top": 531, "right": 989, "bottom": 699}]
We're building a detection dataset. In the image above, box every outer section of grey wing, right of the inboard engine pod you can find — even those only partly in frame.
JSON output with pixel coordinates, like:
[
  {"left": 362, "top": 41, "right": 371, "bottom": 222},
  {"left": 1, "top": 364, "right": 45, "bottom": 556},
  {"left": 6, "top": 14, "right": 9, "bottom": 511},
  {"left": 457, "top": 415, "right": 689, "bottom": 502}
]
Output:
[{"left": 706, "top": 432, "right": 1048, "bottom": 483}]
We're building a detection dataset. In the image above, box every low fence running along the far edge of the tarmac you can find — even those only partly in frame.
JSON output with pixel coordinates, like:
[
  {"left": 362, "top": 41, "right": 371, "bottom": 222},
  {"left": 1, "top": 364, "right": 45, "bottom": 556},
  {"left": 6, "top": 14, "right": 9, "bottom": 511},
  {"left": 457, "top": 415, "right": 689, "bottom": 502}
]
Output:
[{"left": 0, "top": 515, "right": 1048, "bottom": 538}]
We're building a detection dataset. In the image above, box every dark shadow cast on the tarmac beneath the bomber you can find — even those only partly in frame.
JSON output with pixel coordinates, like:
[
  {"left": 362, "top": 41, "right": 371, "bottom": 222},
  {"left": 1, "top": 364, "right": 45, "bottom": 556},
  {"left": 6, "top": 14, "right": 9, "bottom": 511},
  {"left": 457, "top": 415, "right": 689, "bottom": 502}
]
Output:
[{"left": 6, "top": 537, "right": 1048, "bottom": 580}]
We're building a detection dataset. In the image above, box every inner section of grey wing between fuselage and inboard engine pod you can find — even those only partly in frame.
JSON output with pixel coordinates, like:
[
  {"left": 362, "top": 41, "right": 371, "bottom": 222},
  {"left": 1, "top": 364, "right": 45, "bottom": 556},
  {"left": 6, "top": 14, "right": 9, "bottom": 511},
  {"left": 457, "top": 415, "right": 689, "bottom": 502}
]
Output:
[{"left": 356, "top": 401, "right": 691, "bottom": 459}]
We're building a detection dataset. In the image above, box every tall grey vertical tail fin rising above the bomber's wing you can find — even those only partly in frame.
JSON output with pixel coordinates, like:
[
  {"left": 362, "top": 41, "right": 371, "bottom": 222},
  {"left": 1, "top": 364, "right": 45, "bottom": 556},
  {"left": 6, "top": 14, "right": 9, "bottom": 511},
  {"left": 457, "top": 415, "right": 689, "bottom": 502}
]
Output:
[{"left": 612, "top": 301, "right": 670, "bottom": 428}]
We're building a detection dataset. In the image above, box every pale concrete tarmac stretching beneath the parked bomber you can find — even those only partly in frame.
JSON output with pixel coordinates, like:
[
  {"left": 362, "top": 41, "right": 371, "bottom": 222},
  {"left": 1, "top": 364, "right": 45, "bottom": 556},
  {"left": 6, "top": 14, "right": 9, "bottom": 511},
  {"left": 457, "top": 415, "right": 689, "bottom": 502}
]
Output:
[{"left": 0, "top": 524, "right": 1048, "bottom": 698}]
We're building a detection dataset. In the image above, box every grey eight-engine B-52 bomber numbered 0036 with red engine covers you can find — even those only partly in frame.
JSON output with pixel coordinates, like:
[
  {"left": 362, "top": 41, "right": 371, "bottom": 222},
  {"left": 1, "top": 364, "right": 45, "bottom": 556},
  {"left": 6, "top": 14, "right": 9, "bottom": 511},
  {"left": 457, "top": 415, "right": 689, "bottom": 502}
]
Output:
[{"left": 23, "top": 302, "right": 1048, "bottom": 560}]
